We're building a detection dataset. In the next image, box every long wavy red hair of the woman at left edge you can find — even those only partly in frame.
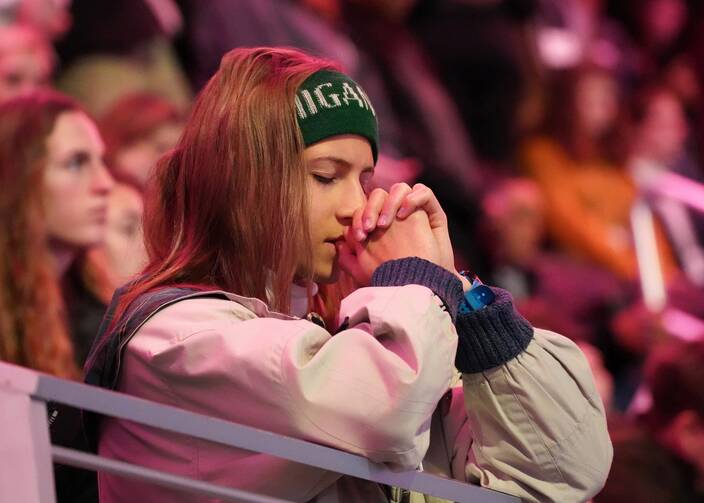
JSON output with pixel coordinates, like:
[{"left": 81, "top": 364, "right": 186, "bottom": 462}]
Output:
[{"left": 0, "top": 91, "right": 81, "bottom": 378}]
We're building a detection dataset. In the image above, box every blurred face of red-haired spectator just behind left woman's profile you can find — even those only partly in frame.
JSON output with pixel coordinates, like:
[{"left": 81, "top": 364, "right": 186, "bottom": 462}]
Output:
[{"left": 113, "top": 122, "right": 183, "bottom": 187}]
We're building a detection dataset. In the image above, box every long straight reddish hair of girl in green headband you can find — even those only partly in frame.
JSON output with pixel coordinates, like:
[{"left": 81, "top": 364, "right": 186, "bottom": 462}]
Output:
[{"left": 110, "top": 48, "right": 346, "bottom": 326}]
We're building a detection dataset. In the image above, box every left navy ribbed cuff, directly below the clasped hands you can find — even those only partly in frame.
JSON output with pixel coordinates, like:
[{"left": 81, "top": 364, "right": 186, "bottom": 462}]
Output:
[{"left": 371, "top": 257, "right": 464, "bottom": 322}]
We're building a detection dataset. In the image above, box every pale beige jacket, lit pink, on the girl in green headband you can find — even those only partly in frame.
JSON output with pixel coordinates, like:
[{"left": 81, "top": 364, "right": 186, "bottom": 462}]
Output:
[{"left": 99, "top": 285, "right": 611, "bottom": 503}]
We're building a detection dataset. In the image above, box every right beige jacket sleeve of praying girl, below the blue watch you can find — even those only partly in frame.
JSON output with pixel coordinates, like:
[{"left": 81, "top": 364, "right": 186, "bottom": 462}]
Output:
[{"left": 434, "top": 329, "right": 613, "bottom": 503}]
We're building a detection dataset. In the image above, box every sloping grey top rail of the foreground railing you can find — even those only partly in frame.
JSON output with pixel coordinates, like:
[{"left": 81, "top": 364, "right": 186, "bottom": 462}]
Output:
[{"left": 0, "top": 362, "right": 520, "bottom": 503}]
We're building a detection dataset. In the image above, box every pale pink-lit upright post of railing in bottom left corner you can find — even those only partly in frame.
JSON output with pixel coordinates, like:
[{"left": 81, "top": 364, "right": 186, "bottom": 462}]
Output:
[{"left": 0, "top": 382, "right": 55, "bottom": 503}]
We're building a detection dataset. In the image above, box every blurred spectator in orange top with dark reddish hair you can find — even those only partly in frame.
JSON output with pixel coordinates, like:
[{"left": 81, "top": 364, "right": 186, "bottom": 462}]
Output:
[{"left": 521, "top": 67, "right": 674, "bottom": 280}]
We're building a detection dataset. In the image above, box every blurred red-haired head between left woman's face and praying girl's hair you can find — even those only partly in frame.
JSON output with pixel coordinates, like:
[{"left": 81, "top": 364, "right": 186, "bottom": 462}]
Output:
[{"left": 100, "top": 94, "right": 184, "bottom": 189}]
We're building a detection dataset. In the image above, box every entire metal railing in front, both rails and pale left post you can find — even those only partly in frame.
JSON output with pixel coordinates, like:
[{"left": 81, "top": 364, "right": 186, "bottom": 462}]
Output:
[{"left": 0, "top": 362, "right": 520, "bottom": 503}]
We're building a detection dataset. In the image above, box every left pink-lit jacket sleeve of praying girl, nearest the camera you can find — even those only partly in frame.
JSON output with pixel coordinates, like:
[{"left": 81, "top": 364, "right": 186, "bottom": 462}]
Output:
[{"left": 127, "top": 285, "right": 457, "bottom": 469}]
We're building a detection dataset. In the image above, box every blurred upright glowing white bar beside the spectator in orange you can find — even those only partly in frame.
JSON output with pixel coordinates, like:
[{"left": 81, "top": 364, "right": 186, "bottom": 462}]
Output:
[{"left": 631, "top": 200, "right": 667, "bottom": 313}]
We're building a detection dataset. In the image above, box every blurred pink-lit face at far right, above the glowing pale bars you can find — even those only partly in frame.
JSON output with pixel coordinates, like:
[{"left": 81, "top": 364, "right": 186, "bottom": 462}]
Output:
[{"left": 636, "top": 91, "right": 689, "bottom": 163}]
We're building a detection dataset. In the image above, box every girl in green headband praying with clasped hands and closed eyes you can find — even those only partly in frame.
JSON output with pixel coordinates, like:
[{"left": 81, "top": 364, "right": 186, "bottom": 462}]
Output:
[{"left": 87, "top": 48, "right": 611, "bottom": 502}]
